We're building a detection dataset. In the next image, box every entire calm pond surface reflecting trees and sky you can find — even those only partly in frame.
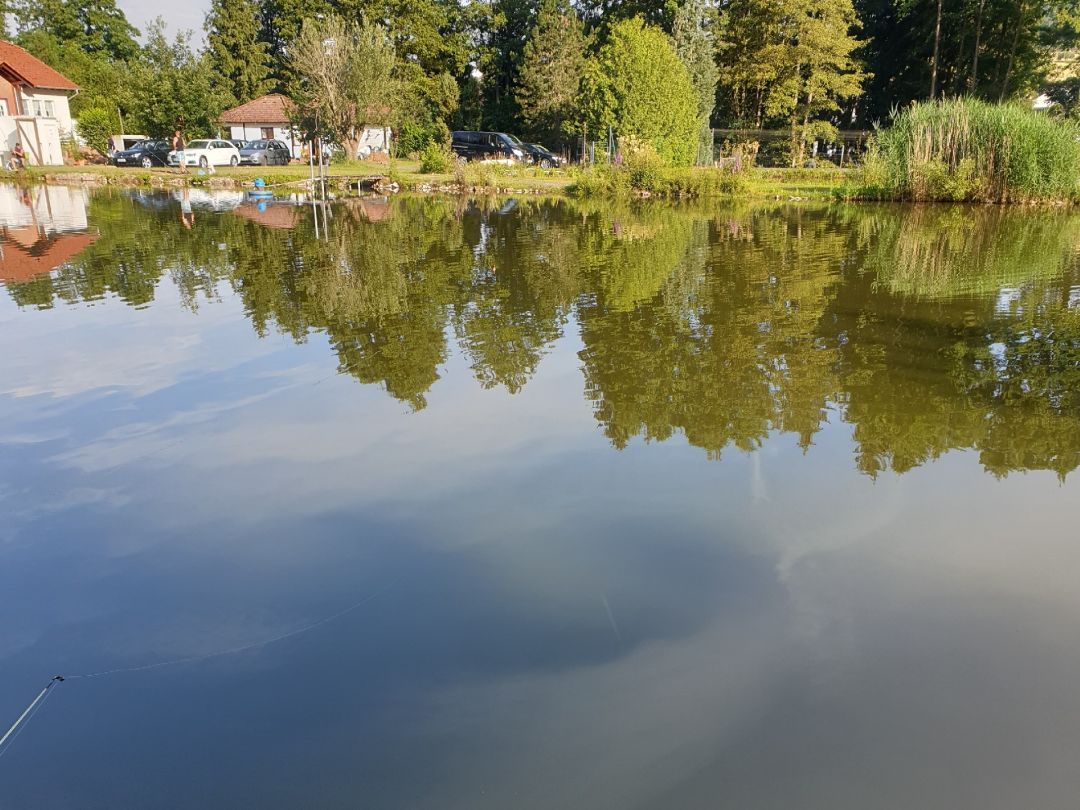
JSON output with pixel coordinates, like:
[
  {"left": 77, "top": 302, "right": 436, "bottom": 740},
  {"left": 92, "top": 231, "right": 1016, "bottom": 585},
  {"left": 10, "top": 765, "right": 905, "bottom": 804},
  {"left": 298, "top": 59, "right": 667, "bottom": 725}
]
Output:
[{"left": 0, "top": 188, "right": 1080, "bottom": 810}]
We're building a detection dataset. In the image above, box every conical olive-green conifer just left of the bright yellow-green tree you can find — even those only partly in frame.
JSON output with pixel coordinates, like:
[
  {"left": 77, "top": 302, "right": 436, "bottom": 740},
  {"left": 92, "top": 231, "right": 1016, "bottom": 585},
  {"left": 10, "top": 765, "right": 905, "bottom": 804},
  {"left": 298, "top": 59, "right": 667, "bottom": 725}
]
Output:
[{"left": 515, "top": 0, "right": 588, "bottom": 141}]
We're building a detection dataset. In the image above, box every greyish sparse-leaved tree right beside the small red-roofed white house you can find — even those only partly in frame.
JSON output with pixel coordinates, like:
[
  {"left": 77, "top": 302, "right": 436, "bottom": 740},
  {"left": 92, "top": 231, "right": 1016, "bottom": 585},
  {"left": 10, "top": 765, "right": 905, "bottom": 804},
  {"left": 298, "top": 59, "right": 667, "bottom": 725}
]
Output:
[{"left": 289, "top": 16, "right": 399, "bottom": 158}]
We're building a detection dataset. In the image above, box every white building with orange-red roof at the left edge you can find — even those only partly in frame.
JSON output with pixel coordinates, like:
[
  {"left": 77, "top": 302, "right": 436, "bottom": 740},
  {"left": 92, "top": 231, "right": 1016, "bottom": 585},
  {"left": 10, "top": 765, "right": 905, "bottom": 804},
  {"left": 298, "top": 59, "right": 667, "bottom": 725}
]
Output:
[{"left": 0, "top": 40, "right": 79, "bottom": 166}]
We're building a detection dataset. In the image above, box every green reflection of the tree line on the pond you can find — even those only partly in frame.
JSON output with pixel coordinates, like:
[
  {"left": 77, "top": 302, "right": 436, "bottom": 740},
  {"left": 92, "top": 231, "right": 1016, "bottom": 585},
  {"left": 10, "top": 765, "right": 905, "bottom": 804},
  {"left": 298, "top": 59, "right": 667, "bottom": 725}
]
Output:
[{"left": 10, "top": 195, "right": 1080, "bottom": 475}]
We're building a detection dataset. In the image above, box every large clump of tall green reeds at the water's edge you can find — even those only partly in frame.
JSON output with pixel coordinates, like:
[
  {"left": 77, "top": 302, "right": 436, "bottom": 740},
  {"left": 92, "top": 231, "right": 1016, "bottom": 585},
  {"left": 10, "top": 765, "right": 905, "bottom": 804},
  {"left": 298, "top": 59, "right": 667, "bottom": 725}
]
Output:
[{"left": 849, "top": 98, "right": 1080, "bottom": 203}]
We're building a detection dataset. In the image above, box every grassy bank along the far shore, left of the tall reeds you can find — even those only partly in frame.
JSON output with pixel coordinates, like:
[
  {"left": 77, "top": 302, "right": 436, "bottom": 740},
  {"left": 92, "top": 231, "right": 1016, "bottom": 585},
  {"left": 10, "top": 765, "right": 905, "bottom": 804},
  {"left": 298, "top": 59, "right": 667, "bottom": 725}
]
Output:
[{"left": 0, "top": 161, "right": 850, "bottom": 200}]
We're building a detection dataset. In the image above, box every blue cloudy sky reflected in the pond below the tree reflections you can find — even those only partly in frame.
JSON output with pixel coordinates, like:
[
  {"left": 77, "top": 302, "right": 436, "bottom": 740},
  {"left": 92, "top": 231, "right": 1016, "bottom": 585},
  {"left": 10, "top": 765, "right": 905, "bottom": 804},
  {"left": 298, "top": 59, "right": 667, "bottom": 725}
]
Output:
[{"left": 0, "top": 198, "right": 1080, "bottom": 809}]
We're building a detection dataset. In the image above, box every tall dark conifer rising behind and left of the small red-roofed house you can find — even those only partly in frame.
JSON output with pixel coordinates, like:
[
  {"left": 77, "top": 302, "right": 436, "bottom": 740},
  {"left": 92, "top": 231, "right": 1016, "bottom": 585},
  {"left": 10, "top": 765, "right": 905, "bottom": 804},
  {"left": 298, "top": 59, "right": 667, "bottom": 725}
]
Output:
[{"left": 205, "top": 0, "right": 273, "bottom": 103}]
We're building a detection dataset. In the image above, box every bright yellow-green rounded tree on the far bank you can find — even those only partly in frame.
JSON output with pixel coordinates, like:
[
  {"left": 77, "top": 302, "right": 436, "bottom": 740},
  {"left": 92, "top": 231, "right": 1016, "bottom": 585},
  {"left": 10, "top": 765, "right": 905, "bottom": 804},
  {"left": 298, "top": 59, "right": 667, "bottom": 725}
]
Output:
[{"left": 581, "top": 17, "right": 698, "bottom": 165}]
